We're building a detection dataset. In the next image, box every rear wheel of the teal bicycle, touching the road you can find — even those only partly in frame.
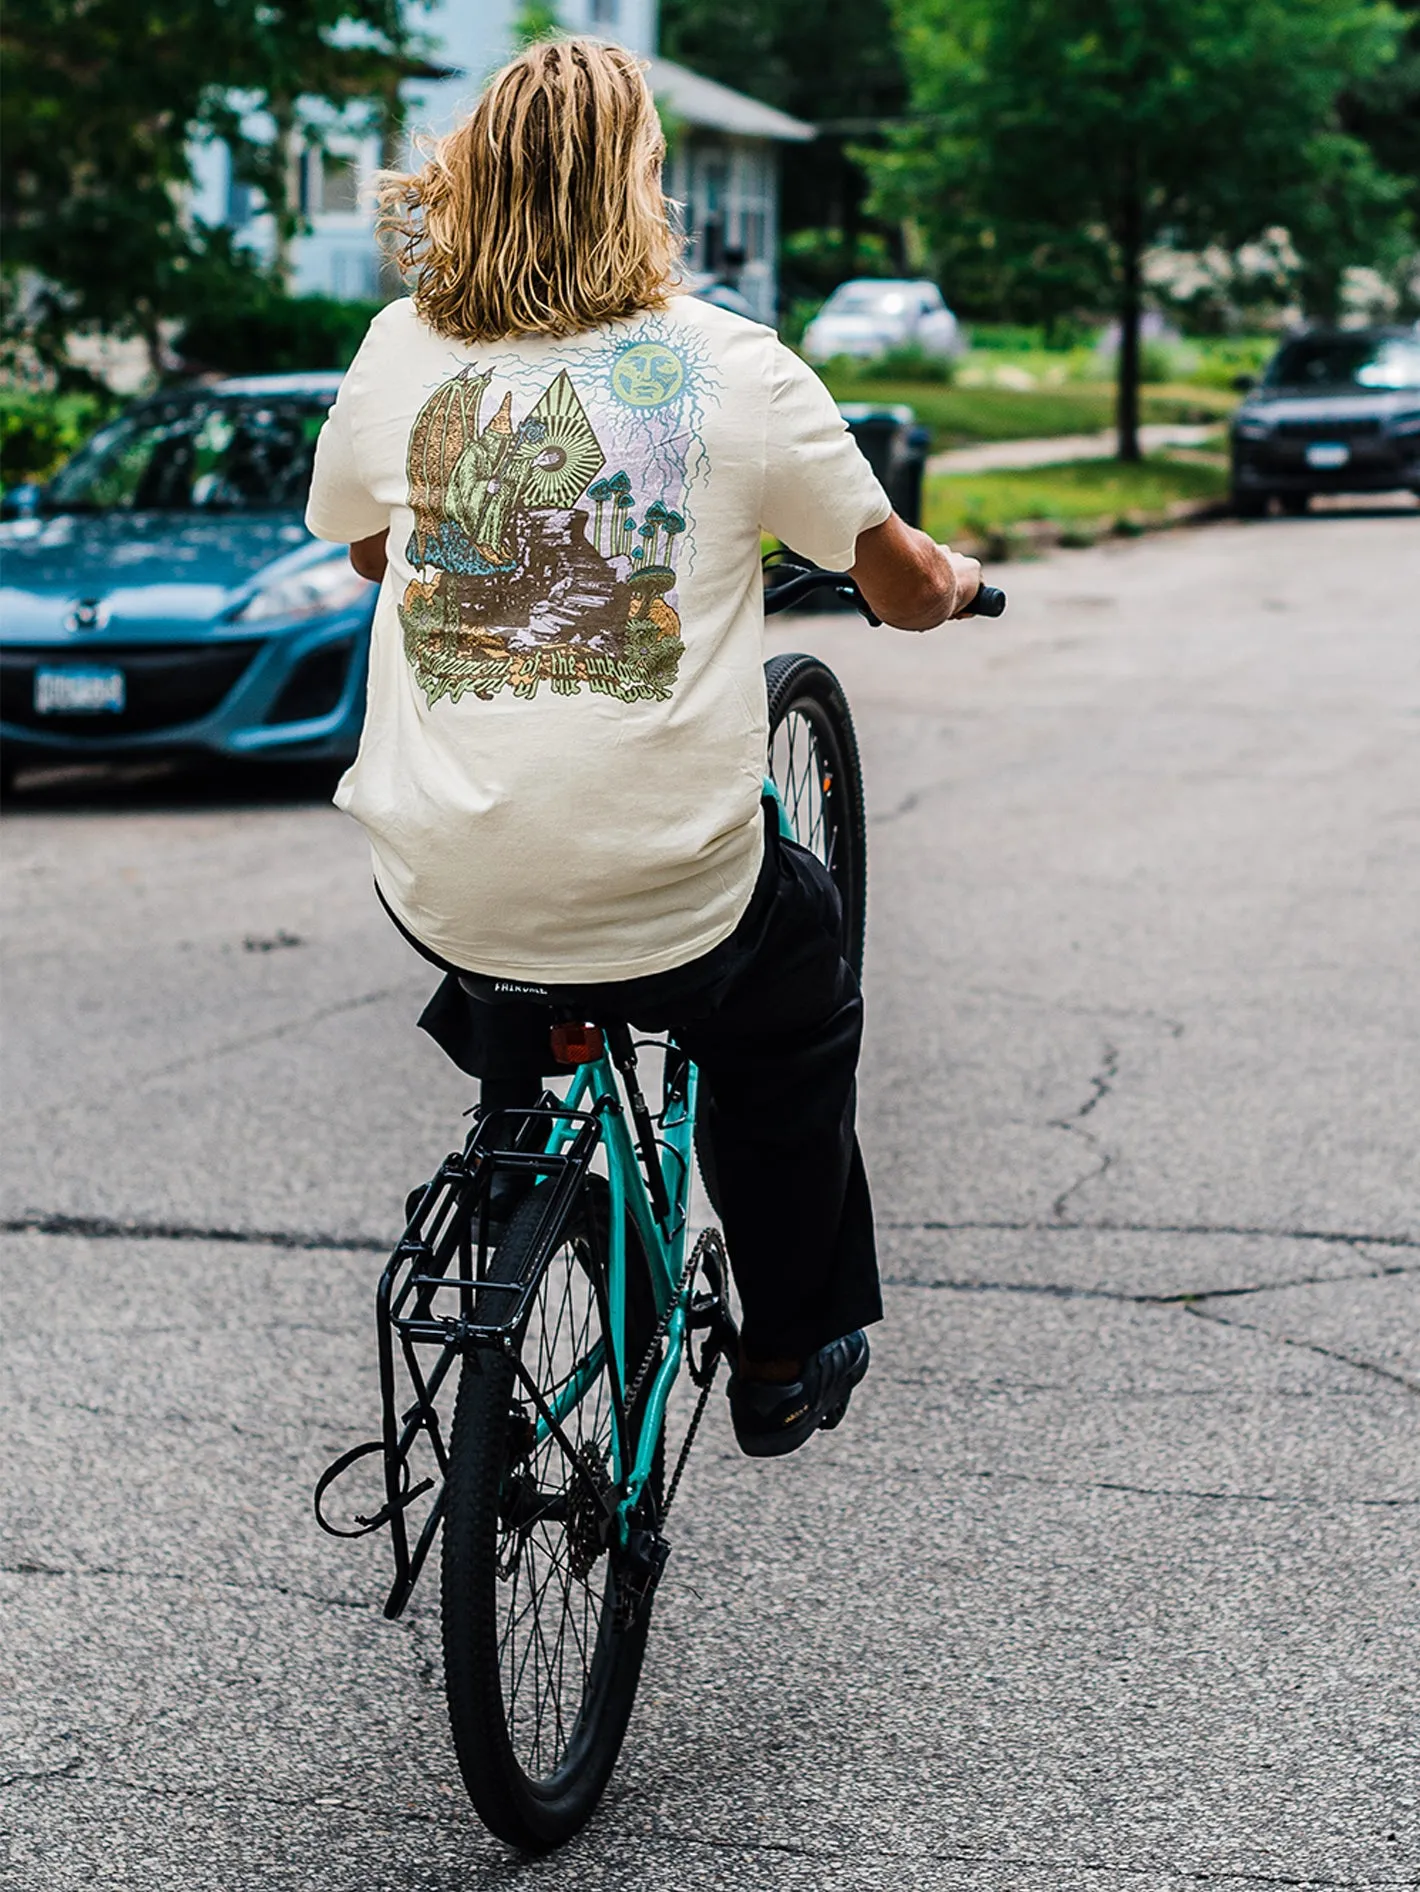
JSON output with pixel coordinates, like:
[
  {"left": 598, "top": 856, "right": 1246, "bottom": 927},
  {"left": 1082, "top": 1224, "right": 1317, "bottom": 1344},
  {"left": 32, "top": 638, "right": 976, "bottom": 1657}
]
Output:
[{"left": 442, "top": 1177, "right": 662, "bottom": 1852}]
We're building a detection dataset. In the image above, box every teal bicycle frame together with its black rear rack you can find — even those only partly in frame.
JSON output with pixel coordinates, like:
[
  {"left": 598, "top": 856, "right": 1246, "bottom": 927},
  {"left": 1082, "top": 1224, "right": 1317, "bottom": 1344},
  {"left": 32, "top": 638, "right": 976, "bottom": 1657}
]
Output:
[{"left": 316, "top": 780, "right": 792, "bottom": 1618}]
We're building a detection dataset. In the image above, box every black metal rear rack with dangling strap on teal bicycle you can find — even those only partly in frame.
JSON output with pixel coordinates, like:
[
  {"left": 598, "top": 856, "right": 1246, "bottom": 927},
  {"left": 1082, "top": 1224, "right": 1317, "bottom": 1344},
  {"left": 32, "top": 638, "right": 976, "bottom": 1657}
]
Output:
[{"left": 316, "top": 1092, "right": 607, "bottom": 1618}]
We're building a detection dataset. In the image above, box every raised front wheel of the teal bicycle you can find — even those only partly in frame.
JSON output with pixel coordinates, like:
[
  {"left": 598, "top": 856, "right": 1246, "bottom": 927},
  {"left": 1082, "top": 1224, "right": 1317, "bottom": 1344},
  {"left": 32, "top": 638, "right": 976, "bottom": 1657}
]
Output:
[{"left": 764, "top": 653, "right": 868, "bottom": 976}]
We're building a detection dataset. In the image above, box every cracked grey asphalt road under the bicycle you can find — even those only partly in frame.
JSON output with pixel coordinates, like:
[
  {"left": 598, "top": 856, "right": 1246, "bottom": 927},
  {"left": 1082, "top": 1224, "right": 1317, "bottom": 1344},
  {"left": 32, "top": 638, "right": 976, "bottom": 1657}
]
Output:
[{"left": 0, "top": 515, "right": 1420, "bottom": 1892}]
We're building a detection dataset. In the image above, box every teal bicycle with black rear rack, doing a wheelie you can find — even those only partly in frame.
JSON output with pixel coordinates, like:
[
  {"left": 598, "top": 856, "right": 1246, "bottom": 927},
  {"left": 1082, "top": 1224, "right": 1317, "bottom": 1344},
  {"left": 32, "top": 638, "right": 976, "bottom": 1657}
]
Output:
[{"left": 316, "top": 568, "right": 1005, "bottom": 1850}]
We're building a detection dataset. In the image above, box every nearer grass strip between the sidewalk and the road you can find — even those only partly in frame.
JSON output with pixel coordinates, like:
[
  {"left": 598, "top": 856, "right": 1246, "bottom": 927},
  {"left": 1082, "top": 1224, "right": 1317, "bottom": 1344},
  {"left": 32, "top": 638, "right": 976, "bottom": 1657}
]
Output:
[{"left": 923, "top": 456, "right": 1227, "bottom": 539}]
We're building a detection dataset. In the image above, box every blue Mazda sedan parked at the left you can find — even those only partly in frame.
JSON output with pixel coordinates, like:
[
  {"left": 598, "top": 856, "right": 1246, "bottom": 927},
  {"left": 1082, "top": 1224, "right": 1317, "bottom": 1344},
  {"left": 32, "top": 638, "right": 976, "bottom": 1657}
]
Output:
[{"left": 0, "top": 375, "right": 376, "bottom": 776}]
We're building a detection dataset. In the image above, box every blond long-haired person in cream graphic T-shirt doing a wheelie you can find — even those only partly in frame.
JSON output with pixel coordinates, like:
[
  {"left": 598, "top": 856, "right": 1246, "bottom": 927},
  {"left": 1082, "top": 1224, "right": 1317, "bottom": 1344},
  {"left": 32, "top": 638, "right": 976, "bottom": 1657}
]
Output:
[{"left": 306, "top": 38, "right": 981, "bottom": 1457}]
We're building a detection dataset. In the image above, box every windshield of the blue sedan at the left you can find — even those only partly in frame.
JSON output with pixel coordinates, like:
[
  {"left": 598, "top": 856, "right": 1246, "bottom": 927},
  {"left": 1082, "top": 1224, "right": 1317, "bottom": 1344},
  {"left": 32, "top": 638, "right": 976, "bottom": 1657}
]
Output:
[{"left": 45, "top": 395, "right": 327, "bottom": 513}]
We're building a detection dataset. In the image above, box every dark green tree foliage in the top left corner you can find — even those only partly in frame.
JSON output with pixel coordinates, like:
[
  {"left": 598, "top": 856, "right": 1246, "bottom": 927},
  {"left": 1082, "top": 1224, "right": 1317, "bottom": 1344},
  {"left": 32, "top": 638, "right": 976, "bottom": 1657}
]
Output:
[{"left": 0, "top": 0, "right": 408, "bottom": 380}]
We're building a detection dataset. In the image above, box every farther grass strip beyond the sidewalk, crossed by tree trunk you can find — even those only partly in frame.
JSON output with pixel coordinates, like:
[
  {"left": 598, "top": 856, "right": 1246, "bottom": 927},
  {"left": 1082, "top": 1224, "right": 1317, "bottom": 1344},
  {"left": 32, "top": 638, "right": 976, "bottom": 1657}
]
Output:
[{"left": 824, "top": 369, "right": 1237, "bottom": 450}]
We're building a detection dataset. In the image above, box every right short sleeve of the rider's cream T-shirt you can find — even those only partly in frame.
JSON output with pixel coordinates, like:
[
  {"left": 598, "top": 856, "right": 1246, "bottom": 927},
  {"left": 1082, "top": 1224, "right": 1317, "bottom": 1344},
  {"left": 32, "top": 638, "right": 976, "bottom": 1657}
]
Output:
[{"left": 760, "top": 341, "right": 892, "bottom": 571}]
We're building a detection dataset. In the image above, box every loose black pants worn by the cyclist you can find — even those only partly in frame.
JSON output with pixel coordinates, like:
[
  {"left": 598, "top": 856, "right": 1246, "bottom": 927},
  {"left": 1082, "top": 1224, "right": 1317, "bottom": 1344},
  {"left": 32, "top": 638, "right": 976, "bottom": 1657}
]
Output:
[{"left": 391, "top": 812, "right": 883, "bottom": 1360}]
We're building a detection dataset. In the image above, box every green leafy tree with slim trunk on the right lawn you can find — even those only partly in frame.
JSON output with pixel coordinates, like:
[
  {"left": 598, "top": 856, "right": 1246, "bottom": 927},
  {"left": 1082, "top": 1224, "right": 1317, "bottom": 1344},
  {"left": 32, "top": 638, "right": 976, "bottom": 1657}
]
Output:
[{"left": 868, "top": 0, "right": 1403, "bottom": 460}]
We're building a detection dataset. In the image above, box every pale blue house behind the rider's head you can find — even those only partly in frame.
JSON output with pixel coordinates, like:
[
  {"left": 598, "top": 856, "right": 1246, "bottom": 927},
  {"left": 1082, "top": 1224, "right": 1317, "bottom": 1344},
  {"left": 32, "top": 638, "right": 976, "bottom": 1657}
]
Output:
[{"left": 193, "top": 0, "right": 813, "bottom": 322}]
